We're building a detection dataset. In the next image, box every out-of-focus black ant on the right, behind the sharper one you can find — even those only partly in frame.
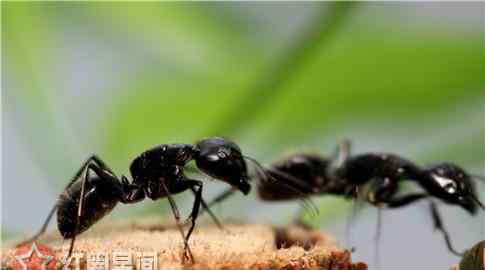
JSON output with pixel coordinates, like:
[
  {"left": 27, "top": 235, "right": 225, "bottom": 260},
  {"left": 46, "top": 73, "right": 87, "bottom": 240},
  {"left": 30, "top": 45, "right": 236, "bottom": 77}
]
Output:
[{"left": 205, "top": 141, "right": 485, "bottom": 255}]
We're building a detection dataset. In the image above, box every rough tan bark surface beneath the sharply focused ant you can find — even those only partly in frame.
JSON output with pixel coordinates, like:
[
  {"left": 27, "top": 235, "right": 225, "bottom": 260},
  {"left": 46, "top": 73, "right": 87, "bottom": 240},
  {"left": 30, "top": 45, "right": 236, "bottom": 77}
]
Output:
[{"left": 2, "top": 219, "right": 367, "bottom": 270}]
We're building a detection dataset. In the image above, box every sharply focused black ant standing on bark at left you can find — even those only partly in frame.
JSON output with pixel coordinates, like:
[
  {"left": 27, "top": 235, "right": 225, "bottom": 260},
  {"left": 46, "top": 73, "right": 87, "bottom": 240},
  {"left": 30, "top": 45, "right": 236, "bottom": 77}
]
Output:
[{"left": 19, "top": 138, "right": 251, "bottom": 261}]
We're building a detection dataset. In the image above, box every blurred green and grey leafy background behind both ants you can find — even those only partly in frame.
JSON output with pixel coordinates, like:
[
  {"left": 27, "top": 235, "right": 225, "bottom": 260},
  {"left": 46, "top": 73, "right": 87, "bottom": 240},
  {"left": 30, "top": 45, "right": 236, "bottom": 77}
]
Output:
[{"left": 1, "top": 2, "right": 485, "bottom": 269}]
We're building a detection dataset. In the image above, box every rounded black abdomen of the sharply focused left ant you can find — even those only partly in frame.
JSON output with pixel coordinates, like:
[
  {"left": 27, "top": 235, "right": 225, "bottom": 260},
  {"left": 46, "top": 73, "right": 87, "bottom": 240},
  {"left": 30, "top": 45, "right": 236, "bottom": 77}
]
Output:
[{"left": 57, "top": 177, "right": 119, "bottom": 238}]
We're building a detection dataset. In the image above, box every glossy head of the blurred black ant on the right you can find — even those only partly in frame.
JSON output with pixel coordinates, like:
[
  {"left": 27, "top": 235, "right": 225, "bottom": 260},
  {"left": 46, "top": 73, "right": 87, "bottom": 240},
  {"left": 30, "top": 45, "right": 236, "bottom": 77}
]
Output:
[{"left": 427, "top": 163, "right": 482, "bottom": 214}]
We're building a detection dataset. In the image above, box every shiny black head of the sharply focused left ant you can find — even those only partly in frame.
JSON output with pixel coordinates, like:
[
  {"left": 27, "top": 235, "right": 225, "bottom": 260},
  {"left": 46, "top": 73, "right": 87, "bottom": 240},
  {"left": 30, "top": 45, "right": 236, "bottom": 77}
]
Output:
[{"left": 195, "top": 138, "right": 251, "bottom": 194}]
